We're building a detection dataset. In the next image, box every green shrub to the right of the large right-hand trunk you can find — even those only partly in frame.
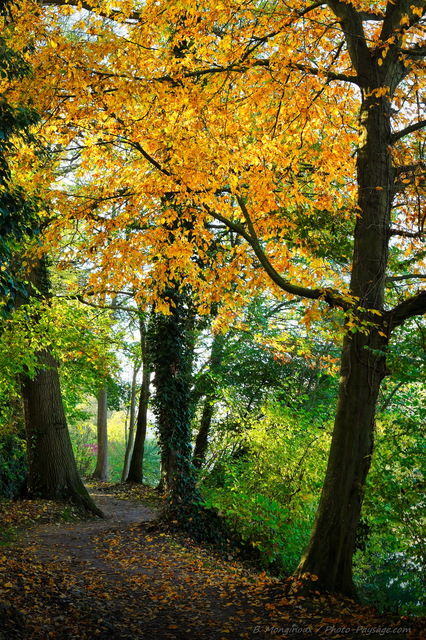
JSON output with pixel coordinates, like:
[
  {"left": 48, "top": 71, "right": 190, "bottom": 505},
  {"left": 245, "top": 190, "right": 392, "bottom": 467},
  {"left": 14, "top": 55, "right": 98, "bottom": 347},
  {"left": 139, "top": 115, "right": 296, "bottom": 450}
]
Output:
[{"left": 354, "top": 412, "right": 426, "bottom": 615}]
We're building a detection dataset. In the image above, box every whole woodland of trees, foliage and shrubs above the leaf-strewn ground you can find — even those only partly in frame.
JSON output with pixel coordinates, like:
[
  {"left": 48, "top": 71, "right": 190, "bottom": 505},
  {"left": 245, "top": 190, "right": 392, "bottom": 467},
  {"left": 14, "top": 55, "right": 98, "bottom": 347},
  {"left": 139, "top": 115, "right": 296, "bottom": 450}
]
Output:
[{"left": 0, "top": 0, "right": 426, "bottom": 612}]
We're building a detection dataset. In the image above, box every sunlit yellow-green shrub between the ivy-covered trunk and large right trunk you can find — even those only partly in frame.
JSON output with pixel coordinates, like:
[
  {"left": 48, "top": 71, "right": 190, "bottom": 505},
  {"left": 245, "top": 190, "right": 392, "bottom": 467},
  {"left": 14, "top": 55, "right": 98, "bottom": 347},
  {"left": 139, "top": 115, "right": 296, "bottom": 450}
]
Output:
[{"left": 201, "top": 406, "right": 329, "bottom": 575}]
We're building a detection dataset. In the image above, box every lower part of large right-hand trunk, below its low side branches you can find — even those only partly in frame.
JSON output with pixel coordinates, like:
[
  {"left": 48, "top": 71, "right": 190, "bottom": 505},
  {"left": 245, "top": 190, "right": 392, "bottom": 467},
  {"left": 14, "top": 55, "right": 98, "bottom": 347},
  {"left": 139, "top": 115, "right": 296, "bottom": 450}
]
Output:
[{"left": 298, "top": 332, "right": 385, "bottom": 596}]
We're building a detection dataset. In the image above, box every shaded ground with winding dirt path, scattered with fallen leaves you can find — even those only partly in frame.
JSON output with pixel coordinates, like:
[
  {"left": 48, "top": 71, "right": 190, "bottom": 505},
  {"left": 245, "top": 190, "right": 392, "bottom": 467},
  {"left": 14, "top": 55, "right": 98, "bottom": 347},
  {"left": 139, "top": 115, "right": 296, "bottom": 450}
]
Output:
[{"left": 0, "top": 486, "right": 426, "bottom": 640}]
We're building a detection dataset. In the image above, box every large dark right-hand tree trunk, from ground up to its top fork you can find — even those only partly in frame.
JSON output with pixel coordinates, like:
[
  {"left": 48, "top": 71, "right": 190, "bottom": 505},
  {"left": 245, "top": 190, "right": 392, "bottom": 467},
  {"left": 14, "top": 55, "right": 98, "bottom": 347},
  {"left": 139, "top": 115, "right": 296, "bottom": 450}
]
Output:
[{"left": 296, "top": 60, "right": 395, "bottom": 596}]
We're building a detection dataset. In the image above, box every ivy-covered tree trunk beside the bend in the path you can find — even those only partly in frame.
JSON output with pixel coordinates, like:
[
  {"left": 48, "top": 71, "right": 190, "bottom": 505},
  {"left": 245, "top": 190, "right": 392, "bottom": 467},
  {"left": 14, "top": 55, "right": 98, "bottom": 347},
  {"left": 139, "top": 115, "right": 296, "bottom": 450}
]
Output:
[{"left": 149, "top": 296, "right": 243, "bottom": 546}]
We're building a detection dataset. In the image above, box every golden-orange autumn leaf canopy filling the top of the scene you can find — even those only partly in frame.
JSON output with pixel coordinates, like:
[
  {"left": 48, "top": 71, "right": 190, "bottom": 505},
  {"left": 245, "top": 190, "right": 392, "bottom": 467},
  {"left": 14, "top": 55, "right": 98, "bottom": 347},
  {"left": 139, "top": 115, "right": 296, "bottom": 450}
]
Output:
[{"left": 3, "top": 0, "right": 423, "bottom": 311}]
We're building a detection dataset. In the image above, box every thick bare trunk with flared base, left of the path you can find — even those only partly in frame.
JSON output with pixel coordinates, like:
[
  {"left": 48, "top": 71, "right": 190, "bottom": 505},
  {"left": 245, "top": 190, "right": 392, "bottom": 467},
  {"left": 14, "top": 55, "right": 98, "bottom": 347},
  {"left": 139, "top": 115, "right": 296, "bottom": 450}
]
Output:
[{"left": 22, "top": 350, "right": 103, "bottom": 517}]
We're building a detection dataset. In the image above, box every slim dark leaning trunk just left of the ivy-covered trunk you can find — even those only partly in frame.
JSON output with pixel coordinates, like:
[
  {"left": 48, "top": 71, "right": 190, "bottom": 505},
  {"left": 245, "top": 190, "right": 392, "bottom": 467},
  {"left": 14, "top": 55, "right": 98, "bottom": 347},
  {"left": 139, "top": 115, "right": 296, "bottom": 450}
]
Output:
[{"left": 126, "top": 316, "right": 151, "bottom": 484}]
